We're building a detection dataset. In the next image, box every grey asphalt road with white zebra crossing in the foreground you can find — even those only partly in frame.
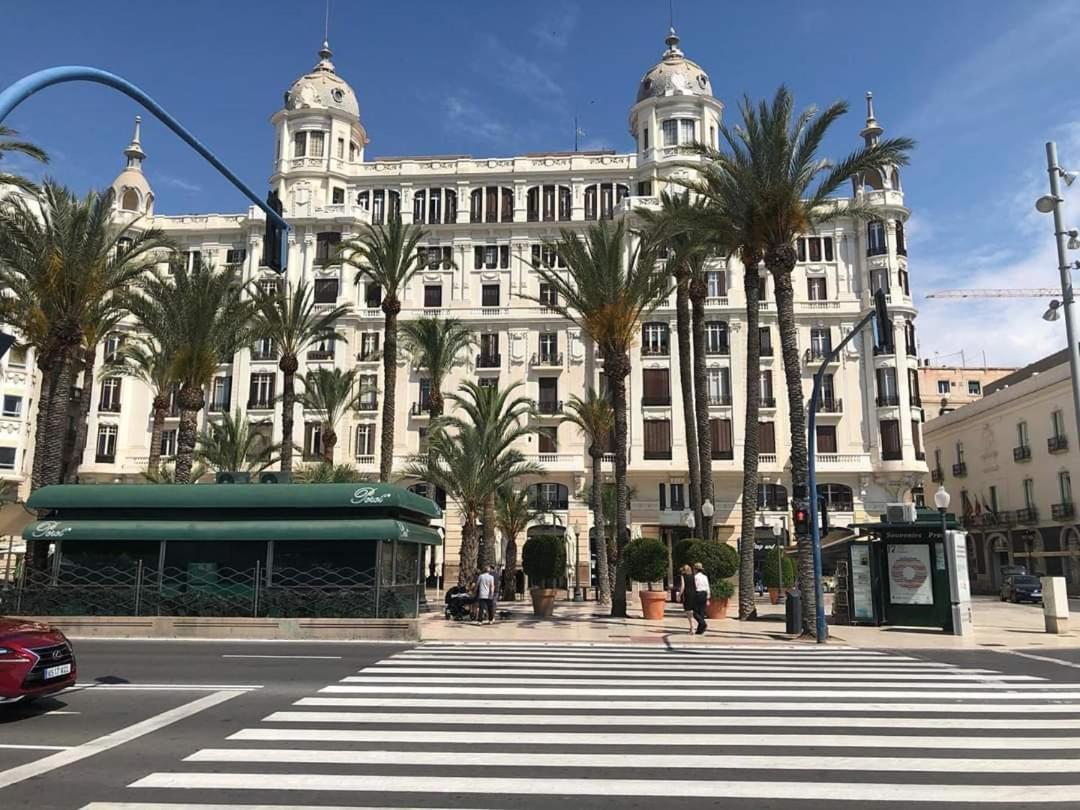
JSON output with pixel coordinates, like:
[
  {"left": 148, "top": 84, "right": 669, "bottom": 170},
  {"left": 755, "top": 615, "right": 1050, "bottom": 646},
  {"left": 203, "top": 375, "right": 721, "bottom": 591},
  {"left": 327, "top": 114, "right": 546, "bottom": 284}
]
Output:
[{"left": 6, "top": 642, "right": 1080, "bottom": 810}]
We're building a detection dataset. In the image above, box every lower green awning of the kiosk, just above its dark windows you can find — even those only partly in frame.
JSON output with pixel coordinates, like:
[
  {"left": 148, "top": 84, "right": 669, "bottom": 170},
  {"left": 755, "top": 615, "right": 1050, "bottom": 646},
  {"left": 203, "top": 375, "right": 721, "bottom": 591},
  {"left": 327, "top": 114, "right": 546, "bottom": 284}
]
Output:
[{"left": 23, "top": 516, "right": 443, "bottom": 545}]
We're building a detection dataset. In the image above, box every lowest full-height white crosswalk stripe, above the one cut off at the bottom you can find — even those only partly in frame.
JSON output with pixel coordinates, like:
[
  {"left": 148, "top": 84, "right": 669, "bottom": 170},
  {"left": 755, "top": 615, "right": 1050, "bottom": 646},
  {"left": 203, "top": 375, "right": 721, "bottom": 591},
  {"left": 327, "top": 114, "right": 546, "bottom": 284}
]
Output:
[{"left": 131, "top": 772, "right": 1063, "bottom": 805}]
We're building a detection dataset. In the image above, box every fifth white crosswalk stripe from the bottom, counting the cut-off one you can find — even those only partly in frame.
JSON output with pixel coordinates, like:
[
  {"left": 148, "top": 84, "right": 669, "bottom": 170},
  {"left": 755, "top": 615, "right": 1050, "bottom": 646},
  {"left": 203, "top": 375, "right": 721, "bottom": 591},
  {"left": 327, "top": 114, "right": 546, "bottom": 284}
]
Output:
[{"left": 262, "top": 703, "right": 1080, "bottom": 734}]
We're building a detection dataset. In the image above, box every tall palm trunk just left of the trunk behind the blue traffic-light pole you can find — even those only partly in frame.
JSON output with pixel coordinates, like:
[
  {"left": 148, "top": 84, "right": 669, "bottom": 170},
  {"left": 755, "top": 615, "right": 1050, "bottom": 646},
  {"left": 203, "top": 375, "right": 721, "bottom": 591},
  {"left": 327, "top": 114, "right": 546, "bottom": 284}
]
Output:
[{"left": 739, "top": 256, "right": 761, "bottom": 621}]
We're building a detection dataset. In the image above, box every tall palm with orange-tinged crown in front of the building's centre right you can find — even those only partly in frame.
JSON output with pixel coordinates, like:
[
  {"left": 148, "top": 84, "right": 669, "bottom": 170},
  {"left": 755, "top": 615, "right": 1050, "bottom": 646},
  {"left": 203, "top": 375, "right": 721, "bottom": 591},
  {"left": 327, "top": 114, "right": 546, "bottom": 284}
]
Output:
[{"left": 535, "top": 221, "right": 672, "bottom": 617}]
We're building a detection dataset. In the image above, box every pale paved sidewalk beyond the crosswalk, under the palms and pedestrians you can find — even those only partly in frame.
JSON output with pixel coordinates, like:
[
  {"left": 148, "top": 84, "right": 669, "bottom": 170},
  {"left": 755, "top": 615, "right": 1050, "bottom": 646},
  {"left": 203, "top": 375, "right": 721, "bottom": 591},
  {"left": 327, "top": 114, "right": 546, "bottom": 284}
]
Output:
[{"left": 420, "top": 592, "right": 1080, "bottom": 649}]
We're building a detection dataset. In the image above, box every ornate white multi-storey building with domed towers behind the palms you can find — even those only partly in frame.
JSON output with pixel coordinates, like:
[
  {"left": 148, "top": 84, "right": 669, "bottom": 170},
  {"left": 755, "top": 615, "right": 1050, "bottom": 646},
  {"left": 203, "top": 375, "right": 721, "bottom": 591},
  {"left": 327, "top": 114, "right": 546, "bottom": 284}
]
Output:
[{"left": 8, "top": 30, "right": 927, "bottom": 577}]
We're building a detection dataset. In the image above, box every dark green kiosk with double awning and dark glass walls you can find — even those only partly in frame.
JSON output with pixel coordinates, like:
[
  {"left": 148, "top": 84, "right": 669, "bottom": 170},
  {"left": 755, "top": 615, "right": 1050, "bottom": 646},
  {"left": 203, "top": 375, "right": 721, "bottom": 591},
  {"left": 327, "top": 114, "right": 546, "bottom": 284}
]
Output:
[{"left": 15, "top": 484, "right": 442, "bottom": 619}]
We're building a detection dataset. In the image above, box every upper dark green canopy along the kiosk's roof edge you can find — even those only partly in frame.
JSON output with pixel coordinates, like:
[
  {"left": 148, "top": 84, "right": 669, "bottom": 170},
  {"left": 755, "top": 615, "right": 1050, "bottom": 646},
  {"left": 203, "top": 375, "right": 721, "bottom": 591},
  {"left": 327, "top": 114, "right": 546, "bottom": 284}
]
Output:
[{"left": 27, "top": 484, "right": 443, "bottom": 519}]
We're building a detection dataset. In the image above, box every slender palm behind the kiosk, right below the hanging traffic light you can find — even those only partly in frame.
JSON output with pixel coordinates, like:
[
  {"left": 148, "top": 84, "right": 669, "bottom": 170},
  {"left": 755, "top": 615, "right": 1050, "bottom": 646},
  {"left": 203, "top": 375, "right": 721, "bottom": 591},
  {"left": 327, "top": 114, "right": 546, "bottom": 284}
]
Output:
[{"left": 252, "top": 281, "right": 349, "bottom": 472}]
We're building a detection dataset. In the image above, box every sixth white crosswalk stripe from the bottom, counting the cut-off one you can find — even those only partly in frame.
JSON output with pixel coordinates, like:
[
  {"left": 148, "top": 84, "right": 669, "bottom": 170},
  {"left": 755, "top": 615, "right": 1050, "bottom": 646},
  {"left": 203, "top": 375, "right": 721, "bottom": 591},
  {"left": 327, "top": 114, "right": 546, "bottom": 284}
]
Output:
[{"left": 293, "top": 690, "right": 1080, "bottom": 715}]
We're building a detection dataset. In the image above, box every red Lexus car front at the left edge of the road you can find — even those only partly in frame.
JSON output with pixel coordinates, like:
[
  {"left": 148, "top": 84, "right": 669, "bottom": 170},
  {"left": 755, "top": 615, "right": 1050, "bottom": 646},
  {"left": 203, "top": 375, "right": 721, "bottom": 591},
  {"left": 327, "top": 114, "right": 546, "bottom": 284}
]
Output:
[{"left": 0, "top": 617, "right": 76, "bottom": 703}]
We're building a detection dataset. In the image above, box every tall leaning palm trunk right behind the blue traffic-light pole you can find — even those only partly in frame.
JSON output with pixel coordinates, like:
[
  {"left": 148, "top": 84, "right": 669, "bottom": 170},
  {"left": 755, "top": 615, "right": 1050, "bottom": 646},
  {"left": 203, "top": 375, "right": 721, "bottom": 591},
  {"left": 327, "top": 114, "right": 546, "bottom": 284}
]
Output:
[{"left": 766, "top": 244, "right": 816, "bottom": 633}]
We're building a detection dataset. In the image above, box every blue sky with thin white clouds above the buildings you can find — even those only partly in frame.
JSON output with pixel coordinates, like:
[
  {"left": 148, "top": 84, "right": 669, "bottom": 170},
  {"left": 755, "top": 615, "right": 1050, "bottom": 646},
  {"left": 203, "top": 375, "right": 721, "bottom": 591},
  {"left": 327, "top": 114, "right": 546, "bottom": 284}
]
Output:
[{"left": 0, "top": 0, "right": 1080, "bottom": 365}]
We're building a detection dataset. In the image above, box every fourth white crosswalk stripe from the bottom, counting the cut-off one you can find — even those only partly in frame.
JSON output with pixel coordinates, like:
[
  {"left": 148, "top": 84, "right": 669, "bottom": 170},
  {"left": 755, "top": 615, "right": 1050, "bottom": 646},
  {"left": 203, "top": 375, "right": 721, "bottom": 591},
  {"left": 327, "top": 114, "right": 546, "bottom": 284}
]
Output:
[{"left": 228, "top": 728, "right": 1080, "bottom": 753}]
